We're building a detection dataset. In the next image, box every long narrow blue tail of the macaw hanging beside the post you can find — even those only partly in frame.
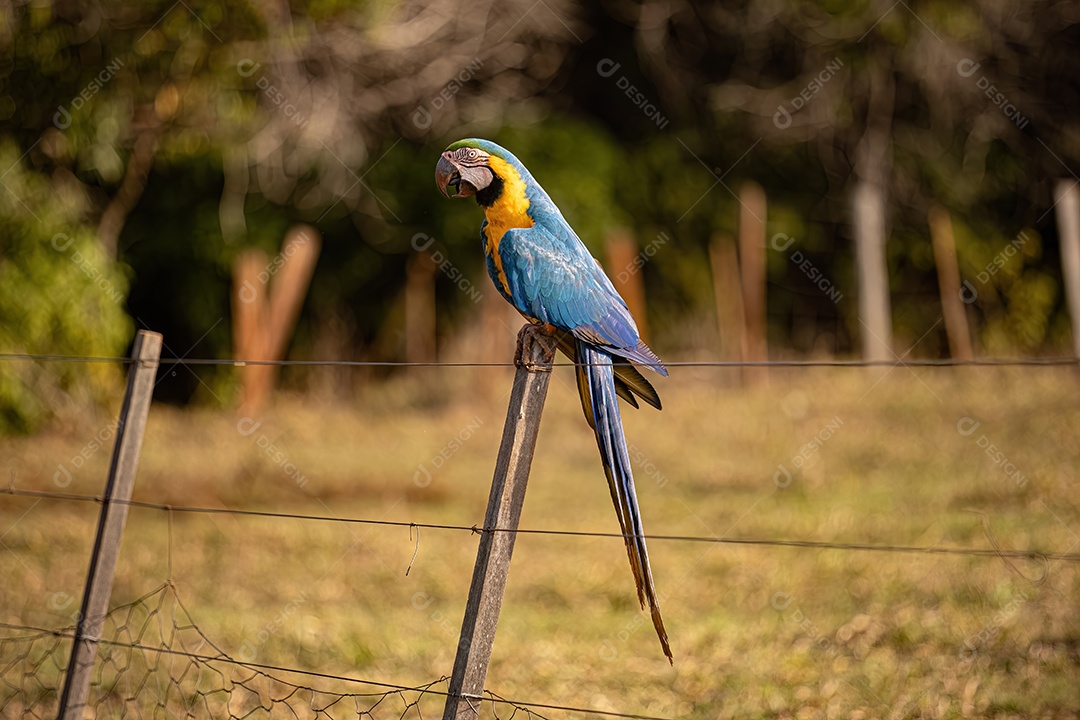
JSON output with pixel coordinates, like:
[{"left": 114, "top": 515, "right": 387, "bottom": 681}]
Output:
[{"left": 576, "top": 340, "right": 675, "bottom": 665}]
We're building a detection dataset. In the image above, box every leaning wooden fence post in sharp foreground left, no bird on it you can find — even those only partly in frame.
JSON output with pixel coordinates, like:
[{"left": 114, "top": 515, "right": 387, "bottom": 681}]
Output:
[{"left": 57, "top": 330, "right": 161, "bottom": 720}]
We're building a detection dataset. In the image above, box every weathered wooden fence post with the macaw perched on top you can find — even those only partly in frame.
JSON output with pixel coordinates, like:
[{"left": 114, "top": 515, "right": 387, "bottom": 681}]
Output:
[{"left": 443, "top": 325, "right": 555, "bottom": 720}]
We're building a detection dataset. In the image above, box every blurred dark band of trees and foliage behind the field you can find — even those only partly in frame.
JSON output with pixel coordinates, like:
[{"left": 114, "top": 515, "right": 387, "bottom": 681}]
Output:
[{"left": 0, "top": 0, "right": 1080, "bottom": 427}]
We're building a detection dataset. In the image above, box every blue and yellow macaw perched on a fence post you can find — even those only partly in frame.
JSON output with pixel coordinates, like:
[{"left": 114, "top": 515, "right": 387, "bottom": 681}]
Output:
[{"left": 435, "top": 138, "right": 674, "bottom": 663}]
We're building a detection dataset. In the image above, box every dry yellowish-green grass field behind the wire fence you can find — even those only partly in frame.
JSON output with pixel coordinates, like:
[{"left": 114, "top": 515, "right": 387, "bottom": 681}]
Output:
[{"left": 0, "top": 367, "right": 1080, "bottom": 719}]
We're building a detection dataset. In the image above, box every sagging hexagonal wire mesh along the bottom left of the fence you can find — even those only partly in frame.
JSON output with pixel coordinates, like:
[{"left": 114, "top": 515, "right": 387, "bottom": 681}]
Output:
[{"left": 0, "top": 583, "right": 548, "bottom": 720}]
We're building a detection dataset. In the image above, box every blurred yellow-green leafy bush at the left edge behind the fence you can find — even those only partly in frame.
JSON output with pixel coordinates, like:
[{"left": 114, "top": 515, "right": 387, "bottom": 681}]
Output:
[{"left": 0, "top": 142, "right": 132, "bottom": 433}]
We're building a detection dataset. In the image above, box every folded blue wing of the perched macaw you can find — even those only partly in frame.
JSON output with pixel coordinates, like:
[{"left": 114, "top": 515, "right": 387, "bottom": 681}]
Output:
[{"left": 488, "top": 218, "right": 667, "bottom": 376}]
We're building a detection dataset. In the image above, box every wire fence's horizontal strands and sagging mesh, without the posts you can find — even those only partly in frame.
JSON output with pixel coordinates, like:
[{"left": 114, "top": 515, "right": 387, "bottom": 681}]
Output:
[{"left": 0, "top": 353, "right": 1080, "bottom": 720}]
